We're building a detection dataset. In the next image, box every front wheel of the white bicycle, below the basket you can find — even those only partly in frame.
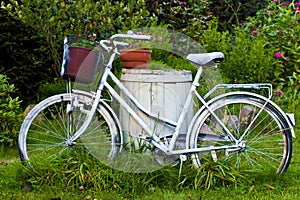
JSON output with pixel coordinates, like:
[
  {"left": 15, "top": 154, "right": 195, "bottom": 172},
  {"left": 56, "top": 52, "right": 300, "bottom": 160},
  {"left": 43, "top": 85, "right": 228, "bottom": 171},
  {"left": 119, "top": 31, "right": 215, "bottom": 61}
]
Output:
[{"left": 18, "top": 93, "right": 122, "bottom": 164}]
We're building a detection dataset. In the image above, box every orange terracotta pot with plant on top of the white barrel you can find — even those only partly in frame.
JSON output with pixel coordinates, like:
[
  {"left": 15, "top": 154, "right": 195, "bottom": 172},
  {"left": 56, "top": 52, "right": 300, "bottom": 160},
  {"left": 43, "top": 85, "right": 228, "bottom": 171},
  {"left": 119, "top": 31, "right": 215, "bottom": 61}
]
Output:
[{"left": 120, "top": 32, "right": 162, "bottom": 69}]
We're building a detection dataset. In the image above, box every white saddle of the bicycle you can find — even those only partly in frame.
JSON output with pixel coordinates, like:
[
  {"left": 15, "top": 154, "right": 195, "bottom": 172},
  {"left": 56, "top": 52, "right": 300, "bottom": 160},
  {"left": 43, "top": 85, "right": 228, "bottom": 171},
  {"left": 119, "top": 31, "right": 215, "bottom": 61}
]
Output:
[{"left": 186, "top": 52, "right": 224, "bottom": 67}]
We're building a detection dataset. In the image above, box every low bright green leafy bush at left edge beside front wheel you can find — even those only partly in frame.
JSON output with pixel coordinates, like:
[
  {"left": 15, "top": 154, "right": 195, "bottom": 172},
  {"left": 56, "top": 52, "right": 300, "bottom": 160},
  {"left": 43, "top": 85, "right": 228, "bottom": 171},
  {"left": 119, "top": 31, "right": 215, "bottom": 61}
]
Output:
[{"left": 0, "top": 74, "right": 22, "bottom": 146}]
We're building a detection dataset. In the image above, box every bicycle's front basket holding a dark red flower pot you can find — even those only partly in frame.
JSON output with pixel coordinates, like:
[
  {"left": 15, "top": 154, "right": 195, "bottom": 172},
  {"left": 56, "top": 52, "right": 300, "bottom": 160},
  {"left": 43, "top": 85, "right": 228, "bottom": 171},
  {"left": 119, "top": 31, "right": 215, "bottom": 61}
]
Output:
[{"left": 61, "top": 34, "right": 100, "bottom": 83}]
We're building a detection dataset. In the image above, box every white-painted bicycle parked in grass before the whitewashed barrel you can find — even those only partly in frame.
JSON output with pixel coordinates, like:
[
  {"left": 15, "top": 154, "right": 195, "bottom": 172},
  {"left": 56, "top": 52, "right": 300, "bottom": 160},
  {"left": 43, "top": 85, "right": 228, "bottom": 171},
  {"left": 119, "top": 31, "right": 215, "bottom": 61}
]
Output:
[{"left": 19, "top": 30, "right": 294, "bottom": 173}]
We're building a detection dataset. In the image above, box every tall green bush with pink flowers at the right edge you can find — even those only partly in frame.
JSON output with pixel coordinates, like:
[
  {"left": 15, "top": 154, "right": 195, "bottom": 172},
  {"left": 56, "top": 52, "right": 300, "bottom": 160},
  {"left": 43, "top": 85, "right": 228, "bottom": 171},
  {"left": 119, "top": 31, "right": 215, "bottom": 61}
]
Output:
[{"left": 244, "top": 1, "right": 300, "bottom": 115}]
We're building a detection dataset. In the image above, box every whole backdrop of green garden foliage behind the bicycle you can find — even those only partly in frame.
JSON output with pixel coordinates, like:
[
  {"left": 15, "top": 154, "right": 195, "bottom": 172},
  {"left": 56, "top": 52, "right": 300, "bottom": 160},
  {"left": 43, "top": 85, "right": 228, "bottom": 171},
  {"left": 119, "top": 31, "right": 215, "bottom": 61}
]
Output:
[{"left": 0, "top": 0, "right": 300, "bottom": 145}]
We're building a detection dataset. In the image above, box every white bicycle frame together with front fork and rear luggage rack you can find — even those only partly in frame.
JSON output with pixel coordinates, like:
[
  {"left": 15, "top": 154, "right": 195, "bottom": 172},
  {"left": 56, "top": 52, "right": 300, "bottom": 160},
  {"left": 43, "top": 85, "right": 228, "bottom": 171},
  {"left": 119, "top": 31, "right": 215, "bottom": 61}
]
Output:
[{"left": 70, "top": 37, "right": 292, "bottom": 155}]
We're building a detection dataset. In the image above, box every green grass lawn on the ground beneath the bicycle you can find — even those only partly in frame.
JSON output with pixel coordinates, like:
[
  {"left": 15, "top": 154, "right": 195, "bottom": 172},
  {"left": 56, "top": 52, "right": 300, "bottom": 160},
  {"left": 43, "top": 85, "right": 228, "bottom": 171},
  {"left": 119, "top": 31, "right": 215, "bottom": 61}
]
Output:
[{"left": 0, "top": 135, "right": 300, "bottom": 200}]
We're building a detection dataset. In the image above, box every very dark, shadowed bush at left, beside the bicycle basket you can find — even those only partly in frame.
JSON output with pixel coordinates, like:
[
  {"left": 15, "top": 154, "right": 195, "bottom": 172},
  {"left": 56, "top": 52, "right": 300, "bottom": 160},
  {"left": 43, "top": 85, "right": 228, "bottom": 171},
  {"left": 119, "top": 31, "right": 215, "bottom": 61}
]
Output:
[{"left": 0, "top": 8, "right": 55, "bottom": 104}]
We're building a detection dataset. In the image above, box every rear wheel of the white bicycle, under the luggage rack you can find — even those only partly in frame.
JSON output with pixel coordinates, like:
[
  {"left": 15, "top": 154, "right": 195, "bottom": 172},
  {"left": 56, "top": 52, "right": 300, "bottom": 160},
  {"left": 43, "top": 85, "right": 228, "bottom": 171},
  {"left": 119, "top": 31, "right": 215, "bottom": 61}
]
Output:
[{"left": 189, "top": 93, "right": 292, "bottom": 173}]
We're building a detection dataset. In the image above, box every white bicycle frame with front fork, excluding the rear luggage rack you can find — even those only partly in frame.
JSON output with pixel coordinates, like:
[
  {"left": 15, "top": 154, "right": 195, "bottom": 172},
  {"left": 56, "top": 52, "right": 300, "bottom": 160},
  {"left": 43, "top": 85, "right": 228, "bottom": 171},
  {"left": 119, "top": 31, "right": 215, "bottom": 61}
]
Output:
[{"left": 70, "top": 50, "right": 246, "bottom": 155}]
